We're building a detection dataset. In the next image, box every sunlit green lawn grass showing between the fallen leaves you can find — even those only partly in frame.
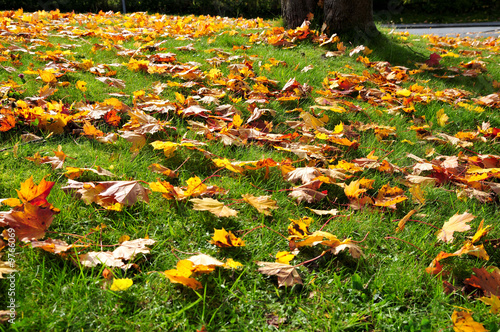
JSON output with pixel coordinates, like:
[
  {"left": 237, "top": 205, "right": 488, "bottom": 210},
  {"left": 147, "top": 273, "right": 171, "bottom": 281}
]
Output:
[{"left": 0, "top": 10, "right": 500, "bottom": 331}]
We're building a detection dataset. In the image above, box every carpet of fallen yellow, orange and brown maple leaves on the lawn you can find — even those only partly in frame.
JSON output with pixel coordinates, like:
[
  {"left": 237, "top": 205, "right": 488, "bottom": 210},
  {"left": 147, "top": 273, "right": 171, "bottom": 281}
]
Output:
[{"left": 0, "top": 10, "right": 500, "bottom": 331}]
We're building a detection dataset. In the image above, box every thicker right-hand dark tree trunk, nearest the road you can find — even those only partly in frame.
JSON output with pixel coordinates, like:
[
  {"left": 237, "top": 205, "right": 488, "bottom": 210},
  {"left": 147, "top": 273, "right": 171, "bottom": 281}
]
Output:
[{"left": 322, "top": 0, "right": 379, "bottom": 38}]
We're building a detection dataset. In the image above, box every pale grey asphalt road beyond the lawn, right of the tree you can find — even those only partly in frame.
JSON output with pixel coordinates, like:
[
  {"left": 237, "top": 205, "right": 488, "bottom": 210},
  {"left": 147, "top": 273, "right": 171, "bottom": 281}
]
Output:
[{"left": 385, "top": 22, "right": 500, "bottom": 38}]
